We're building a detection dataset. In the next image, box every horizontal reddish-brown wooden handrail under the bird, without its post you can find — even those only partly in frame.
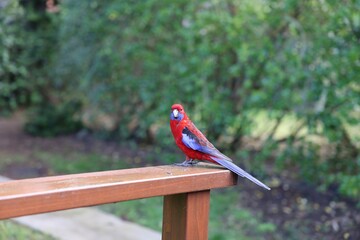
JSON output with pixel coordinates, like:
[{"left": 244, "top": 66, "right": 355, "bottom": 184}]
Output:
[{"left": 0, "top": 164, "right": 237, "bottom": 219}]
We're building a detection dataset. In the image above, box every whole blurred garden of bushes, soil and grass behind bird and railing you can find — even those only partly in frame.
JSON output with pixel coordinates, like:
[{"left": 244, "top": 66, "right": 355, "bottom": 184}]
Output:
[{"left": 0, "top": 0, "right": 360, "bottom": 239}]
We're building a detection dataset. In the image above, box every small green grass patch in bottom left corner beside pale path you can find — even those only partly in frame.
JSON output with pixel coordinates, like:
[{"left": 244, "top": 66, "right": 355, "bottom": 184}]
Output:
[{"left": 0, "top": 220, "right": 54, "bottom": 240}]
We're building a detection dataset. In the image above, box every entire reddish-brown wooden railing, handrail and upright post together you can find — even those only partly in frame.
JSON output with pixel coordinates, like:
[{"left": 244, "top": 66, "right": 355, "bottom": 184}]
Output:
[{"left": 0, "top": 164, "right": 237, "bottom": 240}]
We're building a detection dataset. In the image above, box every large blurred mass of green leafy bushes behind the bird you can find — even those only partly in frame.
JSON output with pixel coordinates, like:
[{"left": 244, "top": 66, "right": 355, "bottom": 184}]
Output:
[{"left": 0, "top": 0, "right": 360, "bottom": 197}]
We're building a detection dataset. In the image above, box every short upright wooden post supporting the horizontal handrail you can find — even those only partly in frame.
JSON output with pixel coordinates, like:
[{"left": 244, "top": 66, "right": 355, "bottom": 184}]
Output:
[{"left": 162, "top": 190, "right": 210, "bottom": 240}]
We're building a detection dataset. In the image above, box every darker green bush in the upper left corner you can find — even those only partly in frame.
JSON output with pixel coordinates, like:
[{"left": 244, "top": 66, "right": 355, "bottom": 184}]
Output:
[{"left": 0, "top": 0, "right": 57, "bottom": 113}]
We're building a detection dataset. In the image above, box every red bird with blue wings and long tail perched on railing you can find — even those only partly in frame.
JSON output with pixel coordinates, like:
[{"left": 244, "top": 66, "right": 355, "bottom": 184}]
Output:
[{"left": 170, "top": 104, "right": 270, "bottom": 190}]
